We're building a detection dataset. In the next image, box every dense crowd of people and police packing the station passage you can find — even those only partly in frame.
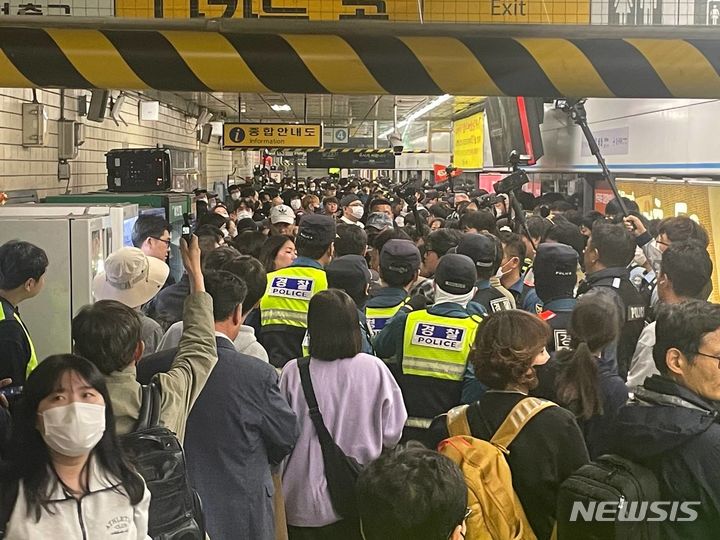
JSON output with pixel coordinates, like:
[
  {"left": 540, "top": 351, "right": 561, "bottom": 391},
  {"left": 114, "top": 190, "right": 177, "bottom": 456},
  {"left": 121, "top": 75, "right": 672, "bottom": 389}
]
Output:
[{"left": 0, "top": 174, "right": 720, "bottom": 540}]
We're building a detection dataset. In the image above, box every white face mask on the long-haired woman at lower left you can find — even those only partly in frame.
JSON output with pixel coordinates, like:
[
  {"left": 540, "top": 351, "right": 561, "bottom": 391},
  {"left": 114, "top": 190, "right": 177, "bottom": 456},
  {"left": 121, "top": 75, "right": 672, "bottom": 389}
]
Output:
[{"left": 41, "top": 402, "right": 105, "bottom": 457}]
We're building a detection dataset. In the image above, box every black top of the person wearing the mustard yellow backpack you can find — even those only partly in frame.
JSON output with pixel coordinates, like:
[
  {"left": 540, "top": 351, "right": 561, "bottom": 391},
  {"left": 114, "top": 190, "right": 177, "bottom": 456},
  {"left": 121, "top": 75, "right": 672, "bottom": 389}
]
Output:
[{"left": 430, "top": 390, "right": 589, "bottom": 540}]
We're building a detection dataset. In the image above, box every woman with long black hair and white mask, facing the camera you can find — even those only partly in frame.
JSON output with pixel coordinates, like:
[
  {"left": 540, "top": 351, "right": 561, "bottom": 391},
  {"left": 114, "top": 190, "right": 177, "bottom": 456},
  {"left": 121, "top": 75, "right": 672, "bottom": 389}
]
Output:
[{"left": 0, "top": 354, "right": 150, "bottom": 540}]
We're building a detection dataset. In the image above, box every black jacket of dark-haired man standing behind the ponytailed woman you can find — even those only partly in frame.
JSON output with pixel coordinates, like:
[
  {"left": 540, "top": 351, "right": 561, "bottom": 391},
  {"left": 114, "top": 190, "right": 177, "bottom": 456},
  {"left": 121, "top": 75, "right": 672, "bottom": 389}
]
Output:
[{"left": 578, "top": 268, "right": 649, "bottom": 380}]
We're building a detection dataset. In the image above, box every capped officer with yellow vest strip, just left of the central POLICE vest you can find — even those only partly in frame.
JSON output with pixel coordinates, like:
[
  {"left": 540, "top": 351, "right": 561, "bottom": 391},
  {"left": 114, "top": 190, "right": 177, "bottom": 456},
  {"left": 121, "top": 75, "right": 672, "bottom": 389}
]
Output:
[{"left": 365, "top": 240, "right": 420, "bottom": 335}]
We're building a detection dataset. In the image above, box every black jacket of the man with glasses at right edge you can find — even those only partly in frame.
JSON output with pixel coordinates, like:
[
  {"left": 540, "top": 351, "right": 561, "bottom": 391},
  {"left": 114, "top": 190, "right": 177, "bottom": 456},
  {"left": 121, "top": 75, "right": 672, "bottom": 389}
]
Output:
[{"left": 613, "top": 375, "right": 720, "bottom": 540}]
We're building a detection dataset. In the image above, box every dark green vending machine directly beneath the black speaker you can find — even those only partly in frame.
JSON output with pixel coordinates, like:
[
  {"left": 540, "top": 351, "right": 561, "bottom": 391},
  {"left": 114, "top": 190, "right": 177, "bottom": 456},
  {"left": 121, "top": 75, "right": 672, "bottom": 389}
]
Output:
[{"left": 44, "top": 191, "right": 195, "bottom": 281}]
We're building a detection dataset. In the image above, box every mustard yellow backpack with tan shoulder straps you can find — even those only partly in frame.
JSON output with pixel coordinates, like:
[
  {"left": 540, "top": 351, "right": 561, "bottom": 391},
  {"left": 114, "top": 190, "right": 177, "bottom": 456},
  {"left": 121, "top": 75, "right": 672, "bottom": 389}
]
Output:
[{"left": 438, "top": 398, "right": 556, "bottom": 540}]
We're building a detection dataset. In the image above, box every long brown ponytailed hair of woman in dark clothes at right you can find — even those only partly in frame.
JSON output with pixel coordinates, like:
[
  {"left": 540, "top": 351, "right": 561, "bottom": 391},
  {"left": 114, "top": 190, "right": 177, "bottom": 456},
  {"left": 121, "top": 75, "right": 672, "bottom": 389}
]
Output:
[{"left": 555, "top": 289, "right": 621, "bottom": 420}]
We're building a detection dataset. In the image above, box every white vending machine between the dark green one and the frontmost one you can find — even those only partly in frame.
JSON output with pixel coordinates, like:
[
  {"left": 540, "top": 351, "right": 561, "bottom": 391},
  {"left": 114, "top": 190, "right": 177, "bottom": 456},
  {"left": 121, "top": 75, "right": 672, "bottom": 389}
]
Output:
[{"left": 0, "top": 203, "right": 139, "bottom": 251}]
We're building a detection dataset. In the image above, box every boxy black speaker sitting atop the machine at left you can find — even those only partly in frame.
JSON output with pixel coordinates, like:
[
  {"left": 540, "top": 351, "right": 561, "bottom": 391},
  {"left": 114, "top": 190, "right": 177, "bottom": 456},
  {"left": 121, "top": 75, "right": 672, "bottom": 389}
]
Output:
[{"left": 105, "top": 148, "right": 172, "bottom": 192}]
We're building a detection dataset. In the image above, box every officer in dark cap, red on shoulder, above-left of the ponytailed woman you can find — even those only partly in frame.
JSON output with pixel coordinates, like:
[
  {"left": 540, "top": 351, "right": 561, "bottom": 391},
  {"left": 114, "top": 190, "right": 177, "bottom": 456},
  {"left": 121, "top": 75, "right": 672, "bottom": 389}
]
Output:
[{"left": 534, "top": 243, "right": 578, "bottom": 352}]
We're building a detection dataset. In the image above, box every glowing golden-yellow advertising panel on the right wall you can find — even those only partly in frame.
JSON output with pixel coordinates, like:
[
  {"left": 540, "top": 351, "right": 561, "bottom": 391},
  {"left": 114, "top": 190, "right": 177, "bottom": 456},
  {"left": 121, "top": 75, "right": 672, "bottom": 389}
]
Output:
[{"left": 618, "top": 181, "right": 720, "bottom": 302}]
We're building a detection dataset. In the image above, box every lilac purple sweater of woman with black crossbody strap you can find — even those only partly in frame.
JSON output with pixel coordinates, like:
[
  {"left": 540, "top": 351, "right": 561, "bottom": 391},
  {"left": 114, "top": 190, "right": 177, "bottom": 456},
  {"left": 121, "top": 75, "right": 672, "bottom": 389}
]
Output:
[{"left": 280, "top": 353, "right": 407, "bottom": 527}]
